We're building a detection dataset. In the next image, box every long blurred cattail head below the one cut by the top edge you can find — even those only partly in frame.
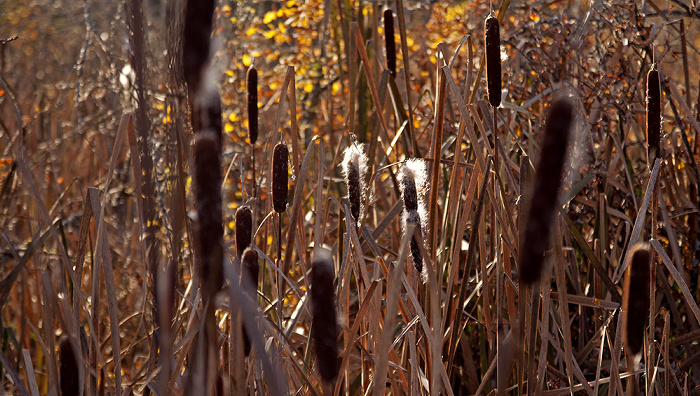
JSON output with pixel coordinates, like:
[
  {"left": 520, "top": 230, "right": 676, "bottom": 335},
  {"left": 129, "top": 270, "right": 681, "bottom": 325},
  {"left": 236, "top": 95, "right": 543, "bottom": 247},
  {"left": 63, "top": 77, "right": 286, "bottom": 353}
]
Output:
[{"left": 193, "top": 132, "right": 224, "bottom": 296}]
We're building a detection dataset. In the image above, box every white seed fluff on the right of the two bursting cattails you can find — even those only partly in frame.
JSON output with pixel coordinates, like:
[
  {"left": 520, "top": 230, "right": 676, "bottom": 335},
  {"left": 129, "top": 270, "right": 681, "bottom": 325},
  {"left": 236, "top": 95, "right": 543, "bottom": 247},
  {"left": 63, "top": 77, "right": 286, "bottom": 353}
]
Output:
[{"left": 398, "top": 158, "right": 428, "bottom": 282}]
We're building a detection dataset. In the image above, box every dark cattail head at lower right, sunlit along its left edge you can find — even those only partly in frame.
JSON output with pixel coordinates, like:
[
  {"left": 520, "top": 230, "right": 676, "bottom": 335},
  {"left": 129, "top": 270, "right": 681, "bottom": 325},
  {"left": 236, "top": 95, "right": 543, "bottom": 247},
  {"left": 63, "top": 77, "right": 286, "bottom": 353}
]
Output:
[{"left": 622, "top": 243, "right": 651, "bottom": 356}]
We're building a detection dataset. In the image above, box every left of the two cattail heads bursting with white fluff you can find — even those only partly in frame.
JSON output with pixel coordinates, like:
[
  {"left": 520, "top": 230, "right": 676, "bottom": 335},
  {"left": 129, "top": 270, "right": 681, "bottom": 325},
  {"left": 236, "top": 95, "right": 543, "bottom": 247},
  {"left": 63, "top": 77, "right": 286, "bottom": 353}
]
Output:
[{"left": 342, "top": 143, "right": 367, "bottom": 222}]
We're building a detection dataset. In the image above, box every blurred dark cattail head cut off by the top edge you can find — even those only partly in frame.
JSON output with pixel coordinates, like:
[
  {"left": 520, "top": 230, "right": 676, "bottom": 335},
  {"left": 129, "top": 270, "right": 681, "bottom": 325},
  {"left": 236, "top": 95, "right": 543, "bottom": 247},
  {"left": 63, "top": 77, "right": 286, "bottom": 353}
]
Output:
[{"left": 182, "top": 0, "right": 216, "bottom": 93}]
